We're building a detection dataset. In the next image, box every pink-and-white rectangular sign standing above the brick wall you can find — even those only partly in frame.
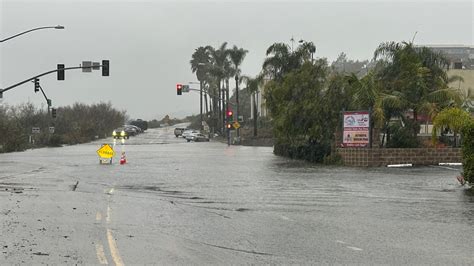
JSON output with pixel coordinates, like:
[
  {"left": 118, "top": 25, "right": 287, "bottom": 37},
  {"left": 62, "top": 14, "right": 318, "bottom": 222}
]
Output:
[{"left": 342, "top": 111, "right": 370, "bottom": 147}]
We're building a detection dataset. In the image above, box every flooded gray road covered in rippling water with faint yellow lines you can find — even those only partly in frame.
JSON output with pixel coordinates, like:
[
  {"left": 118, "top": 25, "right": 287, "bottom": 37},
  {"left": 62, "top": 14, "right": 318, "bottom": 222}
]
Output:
[{"left": 0, "top": 128, "right": 474, "bottom": 265}]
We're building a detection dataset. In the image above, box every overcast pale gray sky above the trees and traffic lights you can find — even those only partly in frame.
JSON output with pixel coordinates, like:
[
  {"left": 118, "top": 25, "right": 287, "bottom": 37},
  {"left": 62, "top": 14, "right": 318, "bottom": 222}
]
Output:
[{"left": 0, "top": 0, "right": 474, "bottom": 119}]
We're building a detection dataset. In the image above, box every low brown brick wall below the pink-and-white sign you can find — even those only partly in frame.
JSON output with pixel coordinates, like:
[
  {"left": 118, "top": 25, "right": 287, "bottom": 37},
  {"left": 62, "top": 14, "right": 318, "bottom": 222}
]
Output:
[{"left": 337, "top": 148, "right": 461, "bottom": 166}]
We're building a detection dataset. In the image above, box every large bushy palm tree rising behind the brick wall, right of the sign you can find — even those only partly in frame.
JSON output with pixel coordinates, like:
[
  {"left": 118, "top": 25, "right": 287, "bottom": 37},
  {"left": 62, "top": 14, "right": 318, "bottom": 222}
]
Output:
[{"left": 374, "top": 42, "right": 457, "bottom": 137}]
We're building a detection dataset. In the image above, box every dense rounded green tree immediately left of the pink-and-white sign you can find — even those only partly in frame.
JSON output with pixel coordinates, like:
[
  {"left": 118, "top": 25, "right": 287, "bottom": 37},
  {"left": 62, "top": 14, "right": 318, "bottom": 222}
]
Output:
[{"left": 264, "top": 60, "right": 332, "bottom": 162}]
